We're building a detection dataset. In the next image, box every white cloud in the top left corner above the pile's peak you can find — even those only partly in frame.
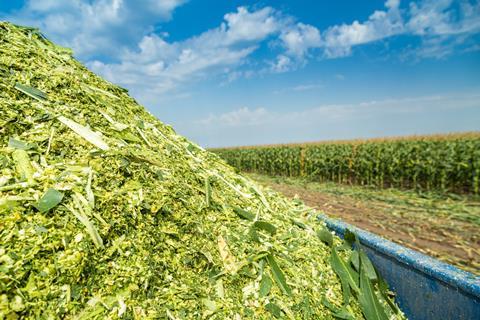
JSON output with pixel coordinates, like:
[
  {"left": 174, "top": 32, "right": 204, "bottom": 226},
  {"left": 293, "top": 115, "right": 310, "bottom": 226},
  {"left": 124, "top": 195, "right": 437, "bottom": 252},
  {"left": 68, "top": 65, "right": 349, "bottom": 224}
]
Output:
[{"left": 2, "top": 0, "right": 186, "bottom": 59}]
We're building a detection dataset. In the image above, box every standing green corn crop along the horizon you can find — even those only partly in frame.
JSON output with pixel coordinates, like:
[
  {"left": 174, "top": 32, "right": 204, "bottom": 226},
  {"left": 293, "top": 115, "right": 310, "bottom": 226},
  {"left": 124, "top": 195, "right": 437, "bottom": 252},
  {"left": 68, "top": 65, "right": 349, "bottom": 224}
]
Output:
[{"left": 212, "top": 133, "right": 480, "bottom": 194}]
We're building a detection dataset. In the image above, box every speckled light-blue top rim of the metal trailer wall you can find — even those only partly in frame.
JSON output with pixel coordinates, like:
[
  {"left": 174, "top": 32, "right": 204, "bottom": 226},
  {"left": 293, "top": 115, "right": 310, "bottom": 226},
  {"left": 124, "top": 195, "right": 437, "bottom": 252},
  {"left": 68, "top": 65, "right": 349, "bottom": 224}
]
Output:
[{"left": 318, "top": 214, "right": 480, "bottom": 299}]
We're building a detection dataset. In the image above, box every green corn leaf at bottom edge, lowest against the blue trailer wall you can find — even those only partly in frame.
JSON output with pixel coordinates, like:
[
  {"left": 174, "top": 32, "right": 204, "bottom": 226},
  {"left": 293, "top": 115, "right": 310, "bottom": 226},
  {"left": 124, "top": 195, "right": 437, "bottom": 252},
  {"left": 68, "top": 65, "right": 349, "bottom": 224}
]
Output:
[{"left": 358, "top": 269, "right": 388, "bottom": 320}]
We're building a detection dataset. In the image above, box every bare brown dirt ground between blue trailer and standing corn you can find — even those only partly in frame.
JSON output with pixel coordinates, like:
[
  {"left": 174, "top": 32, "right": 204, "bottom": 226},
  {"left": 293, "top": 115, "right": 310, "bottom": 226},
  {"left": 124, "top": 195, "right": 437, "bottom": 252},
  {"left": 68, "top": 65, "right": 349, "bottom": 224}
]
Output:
[{"left": 254, "top": 176, "right": 480, "bottom": 275}]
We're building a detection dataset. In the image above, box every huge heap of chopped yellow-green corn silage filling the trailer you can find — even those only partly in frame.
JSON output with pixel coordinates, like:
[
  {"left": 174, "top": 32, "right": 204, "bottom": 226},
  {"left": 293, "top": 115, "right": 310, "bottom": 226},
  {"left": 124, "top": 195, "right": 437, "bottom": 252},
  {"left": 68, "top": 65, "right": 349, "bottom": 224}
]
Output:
[{"left": 0, "top": 22, "right": 403, "bottom": 319}]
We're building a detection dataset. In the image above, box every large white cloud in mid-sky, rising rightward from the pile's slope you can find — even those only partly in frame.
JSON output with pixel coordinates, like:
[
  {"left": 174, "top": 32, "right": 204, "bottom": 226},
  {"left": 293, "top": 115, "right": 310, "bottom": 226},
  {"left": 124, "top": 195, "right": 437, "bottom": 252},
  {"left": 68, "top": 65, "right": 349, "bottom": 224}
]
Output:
[{"left": 89, "top": 7, "right": 320, "bottom": 91}]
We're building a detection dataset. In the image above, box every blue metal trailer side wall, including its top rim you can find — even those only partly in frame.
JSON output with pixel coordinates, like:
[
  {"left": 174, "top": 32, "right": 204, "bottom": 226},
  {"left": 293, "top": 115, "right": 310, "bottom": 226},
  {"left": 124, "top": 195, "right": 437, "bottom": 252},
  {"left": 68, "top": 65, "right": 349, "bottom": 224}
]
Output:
[{"left": 319, "top": 215, "right": 480, "bottom": 320}]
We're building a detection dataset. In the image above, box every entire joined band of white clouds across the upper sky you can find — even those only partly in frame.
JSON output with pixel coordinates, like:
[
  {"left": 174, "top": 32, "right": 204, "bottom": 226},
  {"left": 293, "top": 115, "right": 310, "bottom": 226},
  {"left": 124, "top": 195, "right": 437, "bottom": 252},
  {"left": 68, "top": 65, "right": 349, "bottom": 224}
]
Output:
[{"left": 4, "top": 0, "right": 480, "bottom": 99}]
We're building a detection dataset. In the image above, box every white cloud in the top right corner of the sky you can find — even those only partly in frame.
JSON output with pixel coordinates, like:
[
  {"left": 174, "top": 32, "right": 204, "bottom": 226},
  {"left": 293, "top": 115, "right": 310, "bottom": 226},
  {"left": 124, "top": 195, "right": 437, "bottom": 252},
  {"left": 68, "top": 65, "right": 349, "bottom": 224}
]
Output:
[{"left": 321, "top": 0, "right": 480, "bottom": 60}]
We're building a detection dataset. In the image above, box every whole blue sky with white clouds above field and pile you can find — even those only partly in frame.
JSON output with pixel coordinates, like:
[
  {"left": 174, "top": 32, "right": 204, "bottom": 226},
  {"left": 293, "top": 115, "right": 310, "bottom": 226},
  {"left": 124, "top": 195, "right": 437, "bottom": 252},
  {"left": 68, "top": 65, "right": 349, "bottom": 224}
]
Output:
[{"left": 0, "top": 0, "right": 480, "bottom": 147}]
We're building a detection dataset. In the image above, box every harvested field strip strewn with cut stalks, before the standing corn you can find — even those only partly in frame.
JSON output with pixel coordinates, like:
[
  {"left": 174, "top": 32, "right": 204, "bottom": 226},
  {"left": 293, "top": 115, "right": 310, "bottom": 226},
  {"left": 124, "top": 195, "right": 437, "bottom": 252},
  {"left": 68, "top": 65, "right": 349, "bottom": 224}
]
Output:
[{"left": 249, "top": 174, "right": 480, "bottom": 276}]
